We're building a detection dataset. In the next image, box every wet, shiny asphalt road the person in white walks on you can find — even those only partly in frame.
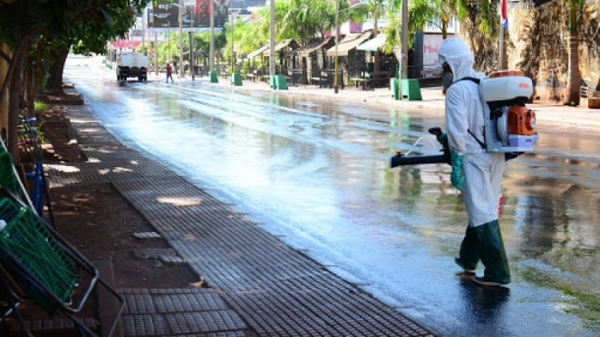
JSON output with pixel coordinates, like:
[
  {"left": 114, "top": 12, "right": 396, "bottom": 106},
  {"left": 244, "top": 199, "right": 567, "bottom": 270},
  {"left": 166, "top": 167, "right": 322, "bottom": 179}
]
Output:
[{"left": 65, "top": 59, "right": 600, "bottom": 336}]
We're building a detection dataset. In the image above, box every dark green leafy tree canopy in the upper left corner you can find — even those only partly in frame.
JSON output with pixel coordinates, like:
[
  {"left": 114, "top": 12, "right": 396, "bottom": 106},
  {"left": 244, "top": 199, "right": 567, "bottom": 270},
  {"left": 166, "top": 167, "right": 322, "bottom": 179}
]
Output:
[{"left": 0, "top": 0, "right": 149, "bottom": 154}]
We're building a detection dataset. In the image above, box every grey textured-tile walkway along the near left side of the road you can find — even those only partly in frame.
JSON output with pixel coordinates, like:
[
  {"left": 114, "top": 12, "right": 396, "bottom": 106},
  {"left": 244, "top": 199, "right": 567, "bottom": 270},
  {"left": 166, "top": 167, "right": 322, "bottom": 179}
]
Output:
[{"left": 49, "top": 106, "right": 434, "bottom": 336}]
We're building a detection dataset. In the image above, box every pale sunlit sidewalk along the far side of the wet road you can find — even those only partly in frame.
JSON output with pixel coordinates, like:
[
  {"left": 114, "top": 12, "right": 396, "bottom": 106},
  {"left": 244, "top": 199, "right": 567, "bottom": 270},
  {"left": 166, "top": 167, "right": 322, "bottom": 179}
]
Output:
[{"left": 158, "top": 74, "right": 600, "bottom": 132}]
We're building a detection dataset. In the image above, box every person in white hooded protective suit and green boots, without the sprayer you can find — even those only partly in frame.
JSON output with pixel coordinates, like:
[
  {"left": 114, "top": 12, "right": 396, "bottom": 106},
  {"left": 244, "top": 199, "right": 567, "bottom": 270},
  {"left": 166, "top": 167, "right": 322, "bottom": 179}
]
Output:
[{"left": 438, "top": 38, "right": 510, "bottom": 286}]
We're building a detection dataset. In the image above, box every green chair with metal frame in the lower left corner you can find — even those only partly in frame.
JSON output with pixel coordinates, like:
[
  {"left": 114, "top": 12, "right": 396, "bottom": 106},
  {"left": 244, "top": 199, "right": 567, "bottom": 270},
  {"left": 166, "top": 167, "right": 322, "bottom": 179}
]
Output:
[{"left": 0, "top": 187, "right": 124, "bottom": 336}]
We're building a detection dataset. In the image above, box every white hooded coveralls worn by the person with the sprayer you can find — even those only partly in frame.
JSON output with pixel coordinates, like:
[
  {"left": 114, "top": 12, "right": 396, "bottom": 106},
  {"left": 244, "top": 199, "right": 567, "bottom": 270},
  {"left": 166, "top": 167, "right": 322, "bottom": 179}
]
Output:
[{"left": 438, "top": 38, "right": 505, "bottom": 227}]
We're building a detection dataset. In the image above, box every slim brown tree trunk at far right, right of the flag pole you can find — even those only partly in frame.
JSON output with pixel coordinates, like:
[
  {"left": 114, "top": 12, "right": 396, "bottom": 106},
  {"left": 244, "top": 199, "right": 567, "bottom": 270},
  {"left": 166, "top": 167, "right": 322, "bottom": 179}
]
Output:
[{"left": 564, "top": 0, "right": 582, "bottom": 105}]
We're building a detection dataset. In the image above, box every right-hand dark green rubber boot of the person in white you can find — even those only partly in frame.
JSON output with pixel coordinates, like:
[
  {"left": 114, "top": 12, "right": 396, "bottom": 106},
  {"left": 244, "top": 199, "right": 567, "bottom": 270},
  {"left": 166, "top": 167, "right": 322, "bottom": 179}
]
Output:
[{"left": 473, "top": 220, "right": 510, "bottom": 286}]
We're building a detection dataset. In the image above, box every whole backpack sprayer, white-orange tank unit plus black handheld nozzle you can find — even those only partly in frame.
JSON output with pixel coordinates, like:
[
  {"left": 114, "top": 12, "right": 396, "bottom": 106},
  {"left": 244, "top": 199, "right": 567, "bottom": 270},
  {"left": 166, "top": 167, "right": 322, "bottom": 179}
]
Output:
[{"left": 390, "top": 70, "right": 539, "bottom": 168}]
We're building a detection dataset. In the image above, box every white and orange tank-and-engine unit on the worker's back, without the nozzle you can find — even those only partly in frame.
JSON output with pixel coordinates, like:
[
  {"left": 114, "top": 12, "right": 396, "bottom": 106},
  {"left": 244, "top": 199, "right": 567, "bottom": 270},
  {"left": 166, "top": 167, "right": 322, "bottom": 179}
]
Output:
[{"left": 480, "top": 70, "right": 539, "bottom": 152}]
